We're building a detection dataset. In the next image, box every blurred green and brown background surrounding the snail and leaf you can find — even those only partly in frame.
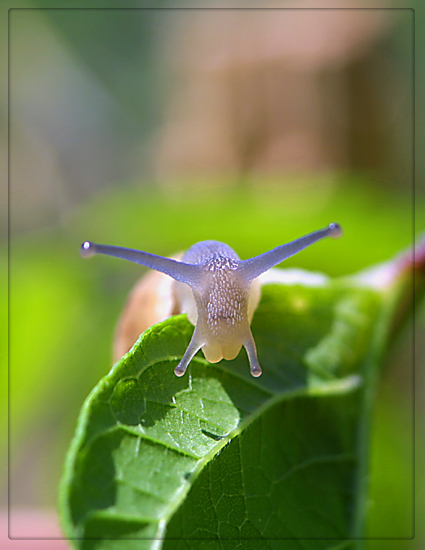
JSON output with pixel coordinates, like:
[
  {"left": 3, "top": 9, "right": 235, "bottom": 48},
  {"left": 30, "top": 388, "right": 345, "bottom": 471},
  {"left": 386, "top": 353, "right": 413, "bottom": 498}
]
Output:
[{"left": 0, "top": 2, "right": 425, "bottom": 549}]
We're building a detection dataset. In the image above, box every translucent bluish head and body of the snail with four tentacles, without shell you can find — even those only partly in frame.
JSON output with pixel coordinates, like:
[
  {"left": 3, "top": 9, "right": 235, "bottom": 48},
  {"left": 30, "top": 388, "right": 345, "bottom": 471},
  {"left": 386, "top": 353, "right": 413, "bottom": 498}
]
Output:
[{"left": 81, "top": 223, "right": 342, "bottom": 376}]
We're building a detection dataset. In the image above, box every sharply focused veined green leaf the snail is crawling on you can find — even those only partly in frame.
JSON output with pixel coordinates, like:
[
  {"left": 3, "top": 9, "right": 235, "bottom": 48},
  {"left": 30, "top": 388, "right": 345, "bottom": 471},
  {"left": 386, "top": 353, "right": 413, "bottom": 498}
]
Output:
[{"left": 60, "top": 251, "right": 412, "bottom": 550}]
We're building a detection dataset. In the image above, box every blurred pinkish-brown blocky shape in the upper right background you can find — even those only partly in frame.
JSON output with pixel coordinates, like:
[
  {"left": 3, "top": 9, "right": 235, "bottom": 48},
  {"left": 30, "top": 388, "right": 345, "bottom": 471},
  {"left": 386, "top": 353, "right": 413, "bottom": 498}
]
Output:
[{"left": 155, "top": 3, "right": 396, "bottom": 180}]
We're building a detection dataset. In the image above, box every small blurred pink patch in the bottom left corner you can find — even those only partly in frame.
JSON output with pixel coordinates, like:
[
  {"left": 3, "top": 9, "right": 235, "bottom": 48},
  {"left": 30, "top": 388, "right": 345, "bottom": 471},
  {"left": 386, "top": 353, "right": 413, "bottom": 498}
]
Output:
[{"left": 0, "top": 509, "right": 69, "bottom": 550}]
